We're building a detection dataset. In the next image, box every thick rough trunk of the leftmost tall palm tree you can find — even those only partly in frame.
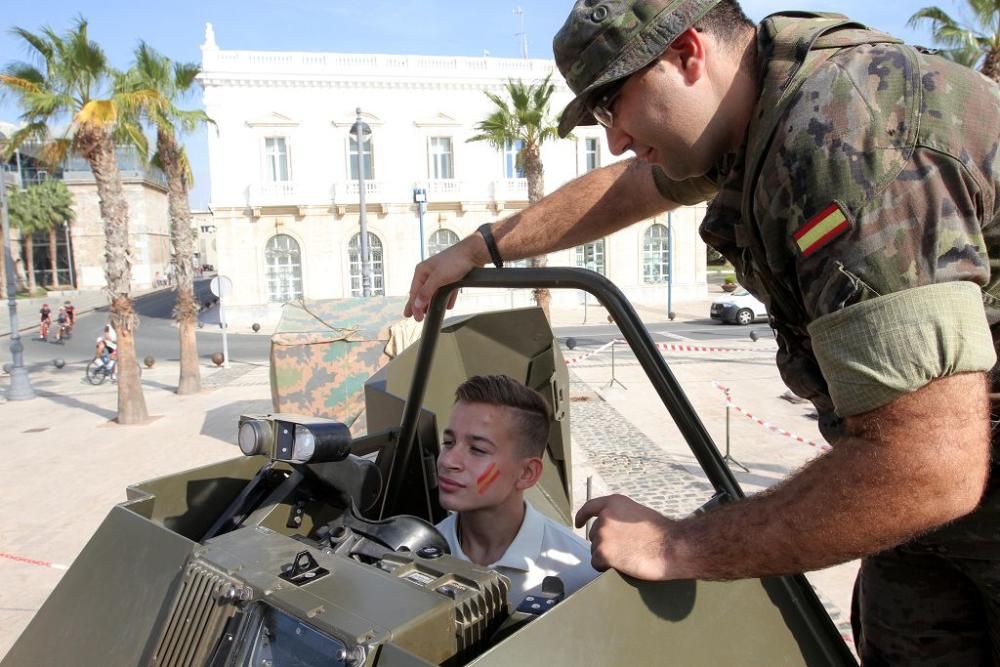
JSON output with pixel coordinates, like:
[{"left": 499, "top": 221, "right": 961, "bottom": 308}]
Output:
[{"left": 82, "top": 127, "right": 149, "bottom": 424}]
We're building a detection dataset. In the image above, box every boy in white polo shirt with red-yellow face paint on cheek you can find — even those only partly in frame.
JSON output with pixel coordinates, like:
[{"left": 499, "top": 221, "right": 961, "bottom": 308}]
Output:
[{"left": 437, "top": 375, "right": 597, "bottom": 609}]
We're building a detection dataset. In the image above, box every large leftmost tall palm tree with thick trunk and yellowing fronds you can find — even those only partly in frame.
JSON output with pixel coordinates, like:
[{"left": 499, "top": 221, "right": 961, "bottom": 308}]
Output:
[{"left": 0, "top": 17, "right": 148, "bottom": 424}]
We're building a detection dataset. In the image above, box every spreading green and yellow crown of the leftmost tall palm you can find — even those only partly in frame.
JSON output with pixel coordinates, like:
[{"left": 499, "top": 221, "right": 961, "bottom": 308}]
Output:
[{"left": 0, "top": 17, "right": 148, "bottom": 164}]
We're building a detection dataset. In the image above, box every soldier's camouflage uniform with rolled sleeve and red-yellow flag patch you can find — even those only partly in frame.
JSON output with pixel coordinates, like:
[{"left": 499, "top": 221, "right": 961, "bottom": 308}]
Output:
[{"left": 556, "top": 0, "right": 1000, "bottom": 665}]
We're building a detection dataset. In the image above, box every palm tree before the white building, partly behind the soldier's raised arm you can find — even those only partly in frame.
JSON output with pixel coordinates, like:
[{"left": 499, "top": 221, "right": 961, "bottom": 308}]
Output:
[{"left": 469, "top": 75, "right": 559, "bottom": 317}]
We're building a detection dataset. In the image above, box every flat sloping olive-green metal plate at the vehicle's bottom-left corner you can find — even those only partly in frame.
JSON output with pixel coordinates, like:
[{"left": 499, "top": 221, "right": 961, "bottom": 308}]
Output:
[{"left": 2, "top": 506, "right": 194, "bottom": 667}]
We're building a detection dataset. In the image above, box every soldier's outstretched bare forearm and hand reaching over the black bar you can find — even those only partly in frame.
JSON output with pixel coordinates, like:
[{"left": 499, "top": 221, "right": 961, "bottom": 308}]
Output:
[{"left": 403, "top": 159, "right": 677, "bottom": 321}]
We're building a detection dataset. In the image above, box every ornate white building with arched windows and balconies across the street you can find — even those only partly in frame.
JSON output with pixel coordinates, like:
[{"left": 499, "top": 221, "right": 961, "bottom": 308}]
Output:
[{"left": 199, "top": 25, "right": 706, "bottom": 328}]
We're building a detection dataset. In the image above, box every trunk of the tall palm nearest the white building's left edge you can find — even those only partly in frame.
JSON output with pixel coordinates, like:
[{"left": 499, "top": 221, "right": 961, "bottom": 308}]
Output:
[{"left": 156, "top": 130, "right": 201, "bottom": 394}]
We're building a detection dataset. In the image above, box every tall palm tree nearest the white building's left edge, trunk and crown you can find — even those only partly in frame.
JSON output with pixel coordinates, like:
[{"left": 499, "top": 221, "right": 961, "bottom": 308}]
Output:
[{"left": 126, "top": 42, "right": 213, "bottom": 394}]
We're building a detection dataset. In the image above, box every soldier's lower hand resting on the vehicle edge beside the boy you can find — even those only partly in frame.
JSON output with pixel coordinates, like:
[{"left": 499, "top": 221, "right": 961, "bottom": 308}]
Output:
[{"left": 576, "top": 494, "right": 673, "bottom": 581}]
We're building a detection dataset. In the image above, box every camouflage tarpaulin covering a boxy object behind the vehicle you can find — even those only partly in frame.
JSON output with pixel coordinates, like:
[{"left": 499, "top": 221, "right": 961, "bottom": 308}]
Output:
[{"left": 271, "top": 297, "right": 419, "bottom": 435}]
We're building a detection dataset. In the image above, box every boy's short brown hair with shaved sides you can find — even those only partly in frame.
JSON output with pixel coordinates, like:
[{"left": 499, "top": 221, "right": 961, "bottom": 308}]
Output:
[{"left": 455, "top": 375, "right": 552, "bottom": 458}]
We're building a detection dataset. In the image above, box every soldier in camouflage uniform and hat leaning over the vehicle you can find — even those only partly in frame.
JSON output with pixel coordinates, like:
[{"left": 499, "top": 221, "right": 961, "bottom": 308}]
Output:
[{"left": 405, "top": 0, "right": 1000, "bottom": 665}]
